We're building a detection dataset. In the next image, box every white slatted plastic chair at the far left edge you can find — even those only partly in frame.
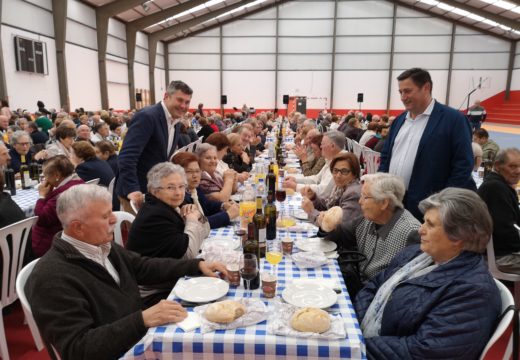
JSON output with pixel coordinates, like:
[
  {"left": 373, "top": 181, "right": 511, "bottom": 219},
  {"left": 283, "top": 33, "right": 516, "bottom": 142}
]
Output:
[{"left": 0, "top": 216, "right": 38, "bottom": 360}]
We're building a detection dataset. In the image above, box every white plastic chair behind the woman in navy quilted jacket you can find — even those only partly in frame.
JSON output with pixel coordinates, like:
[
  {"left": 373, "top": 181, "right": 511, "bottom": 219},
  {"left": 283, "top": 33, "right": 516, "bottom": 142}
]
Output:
[{"left": 480, "top": 279, "right": 515, "bottom": 360}]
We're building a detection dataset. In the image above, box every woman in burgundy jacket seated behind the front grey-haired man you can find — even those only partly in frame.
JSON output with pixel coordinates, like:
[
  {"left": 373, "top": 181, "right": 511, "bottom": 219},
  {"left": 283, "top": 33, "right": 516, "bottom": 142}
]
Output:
[{"left": 32, "top": 155, "right": 84, "bottom": 257}]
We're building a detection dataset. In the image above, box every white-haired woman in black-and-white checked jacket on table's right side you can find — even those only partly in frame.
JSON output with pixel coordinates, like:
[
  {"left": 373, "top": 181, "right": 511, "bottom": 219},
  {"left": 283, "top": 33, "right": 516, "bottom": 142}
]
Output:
[{"left": 327, "top": 173, "right": 421, "bottom": 298}]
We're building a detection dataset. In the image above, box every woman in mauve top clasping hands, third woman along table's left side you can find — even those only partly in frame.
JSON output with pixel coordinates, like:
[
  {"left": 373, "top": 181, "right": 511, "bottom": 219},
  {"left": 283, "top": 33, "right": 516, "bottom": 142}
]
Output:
[{"left": 195, "top": 144, "right": 238, "bottom": 202}]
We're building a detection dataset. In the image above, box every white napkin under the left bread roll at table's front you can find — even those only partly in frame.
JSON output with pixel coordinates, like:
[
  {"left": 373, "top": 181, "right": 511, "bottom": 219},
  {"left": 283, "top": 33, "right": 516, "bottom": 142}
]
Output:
[{"left": 193, "top": 299, "right": 268, "bottom": 334}]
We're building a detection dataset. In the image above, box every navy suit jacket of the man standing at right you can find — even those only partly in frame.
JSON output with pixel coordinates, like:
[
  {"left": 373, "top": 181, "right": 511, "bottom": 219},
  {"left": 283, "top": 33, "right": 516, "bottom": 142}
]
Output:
[{"left": 379, "top": 102, "right": 476, "bottom": 219}]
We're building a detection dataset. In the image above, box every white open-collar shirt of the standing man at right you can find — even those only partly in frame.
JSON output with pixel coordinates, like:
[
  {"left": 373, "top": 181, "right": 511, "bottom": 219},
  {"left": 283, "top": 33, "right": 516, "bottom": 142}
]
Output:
[{"left": 388, "top": 99, "right": 435, "bottom": 189}]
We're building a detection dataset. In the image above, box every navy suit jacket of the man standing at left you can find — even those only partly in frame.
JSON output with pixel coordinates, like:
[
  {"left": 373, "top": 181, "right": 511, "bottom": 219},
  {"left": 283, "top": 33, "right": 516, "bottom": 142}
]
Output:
[{"left": 115, "top": 103, "right": 188, "bottom": 197}]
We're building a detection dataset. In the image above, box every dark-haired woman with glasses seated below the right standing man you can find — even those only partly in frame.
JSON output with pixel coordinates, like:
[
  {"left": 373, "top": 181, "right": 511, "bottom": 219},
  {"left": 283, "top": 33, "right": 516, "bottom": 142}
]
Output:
[{"left": 302, "top": 153, "right": 361, "bottom": 226}]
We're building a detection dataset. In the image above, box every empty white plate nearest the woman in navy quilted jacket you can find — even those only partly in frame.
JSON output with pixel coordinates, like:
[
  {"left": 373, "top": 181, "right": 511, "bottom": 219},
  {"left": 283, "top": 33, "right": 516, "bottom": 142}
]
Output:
[{"left": 282, "top": 283, "right": 338, "bottom": 309}]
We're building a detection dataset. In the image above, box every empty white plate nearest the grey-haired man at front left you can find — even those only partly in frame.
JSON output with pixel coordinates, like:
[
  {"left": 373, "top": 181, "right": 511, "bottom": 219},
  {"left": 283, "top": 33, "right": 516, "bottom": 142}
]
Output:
[{"left": 175, "top": 277, "right": 229, "bottom": 303}]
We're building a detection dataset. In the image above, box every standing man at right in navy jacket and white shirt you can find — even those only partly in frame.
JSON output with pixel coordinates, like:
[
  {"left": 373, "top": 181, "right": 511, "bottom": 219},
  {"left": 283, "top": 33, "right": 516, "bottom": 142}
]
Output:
[{"left": 379, "top": 68, "right": 476, "bottom": 220}]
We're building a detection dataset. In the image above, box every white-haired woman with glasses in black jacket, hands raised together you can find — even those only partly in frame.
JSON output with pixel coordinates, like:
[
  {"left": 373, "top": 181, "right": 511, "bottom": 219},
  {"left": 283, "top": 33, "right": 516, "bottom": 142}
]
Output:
[{"left": 126, "top": 162, "right": 210, "bottom": 259}]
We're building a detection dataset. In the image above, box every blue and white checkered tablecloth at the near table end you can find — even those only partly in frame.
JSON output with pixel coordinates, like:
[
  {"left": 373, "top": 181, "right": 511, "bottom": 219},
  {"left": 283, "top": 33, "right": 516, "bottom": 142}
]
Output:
[{"left": 123, "top": 227, "right": 366, "bottom": 360}]
